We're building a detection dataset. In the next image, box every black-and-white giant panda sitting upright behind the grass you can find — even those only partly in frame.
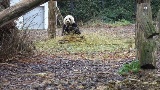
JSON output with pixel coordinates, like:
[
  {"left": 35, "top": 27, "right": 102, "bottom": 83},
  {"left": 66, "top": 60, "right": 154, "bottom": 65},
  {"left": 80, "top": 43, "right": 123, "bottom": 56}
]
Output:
[{"left": 62, "top": 15, "right": 81, "bottom": 36}]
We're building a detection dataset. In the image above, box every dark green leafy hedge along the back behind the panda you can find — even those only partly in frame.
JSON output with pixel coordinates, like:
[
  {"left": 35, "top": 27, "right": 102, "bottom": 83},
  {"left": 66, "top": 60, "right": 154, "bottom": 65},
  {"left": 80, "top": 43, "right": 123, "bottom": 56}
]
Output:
[{"left": 58, "top": 0, "right": 160, "bottom": 23}]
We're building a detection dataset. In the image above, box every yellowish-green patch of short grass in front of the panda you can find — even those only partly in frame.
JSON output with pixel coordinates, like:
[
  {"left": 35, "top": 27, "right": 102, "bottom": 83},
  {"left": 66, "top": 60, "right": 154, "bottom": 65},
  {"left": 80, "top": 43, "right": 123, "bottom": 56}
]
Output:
[{"left": 36, "top": 33, "right": 134, "bottom": 54}]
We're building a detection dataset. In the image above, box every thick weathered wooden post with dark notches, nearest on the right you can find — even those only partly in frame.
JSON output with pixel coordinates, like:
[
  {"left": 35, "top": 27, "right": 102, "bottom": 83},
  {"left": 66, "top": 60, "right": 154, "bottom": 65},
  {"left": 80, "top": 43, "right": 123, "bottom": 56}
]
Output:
[{"left": 136, "top": 0, "right": 159, "bottom": 69}]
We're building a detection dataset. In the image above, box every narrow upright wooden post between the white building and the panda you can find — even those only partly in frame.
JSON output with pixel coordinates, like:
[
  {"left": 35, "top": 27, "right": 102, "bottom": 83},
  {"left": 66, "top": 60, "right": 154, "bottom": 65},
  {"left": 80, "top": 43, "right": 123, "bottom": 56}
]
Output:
[{"left": 48, "top": 0, "right": 57, "bottom": 38}]
